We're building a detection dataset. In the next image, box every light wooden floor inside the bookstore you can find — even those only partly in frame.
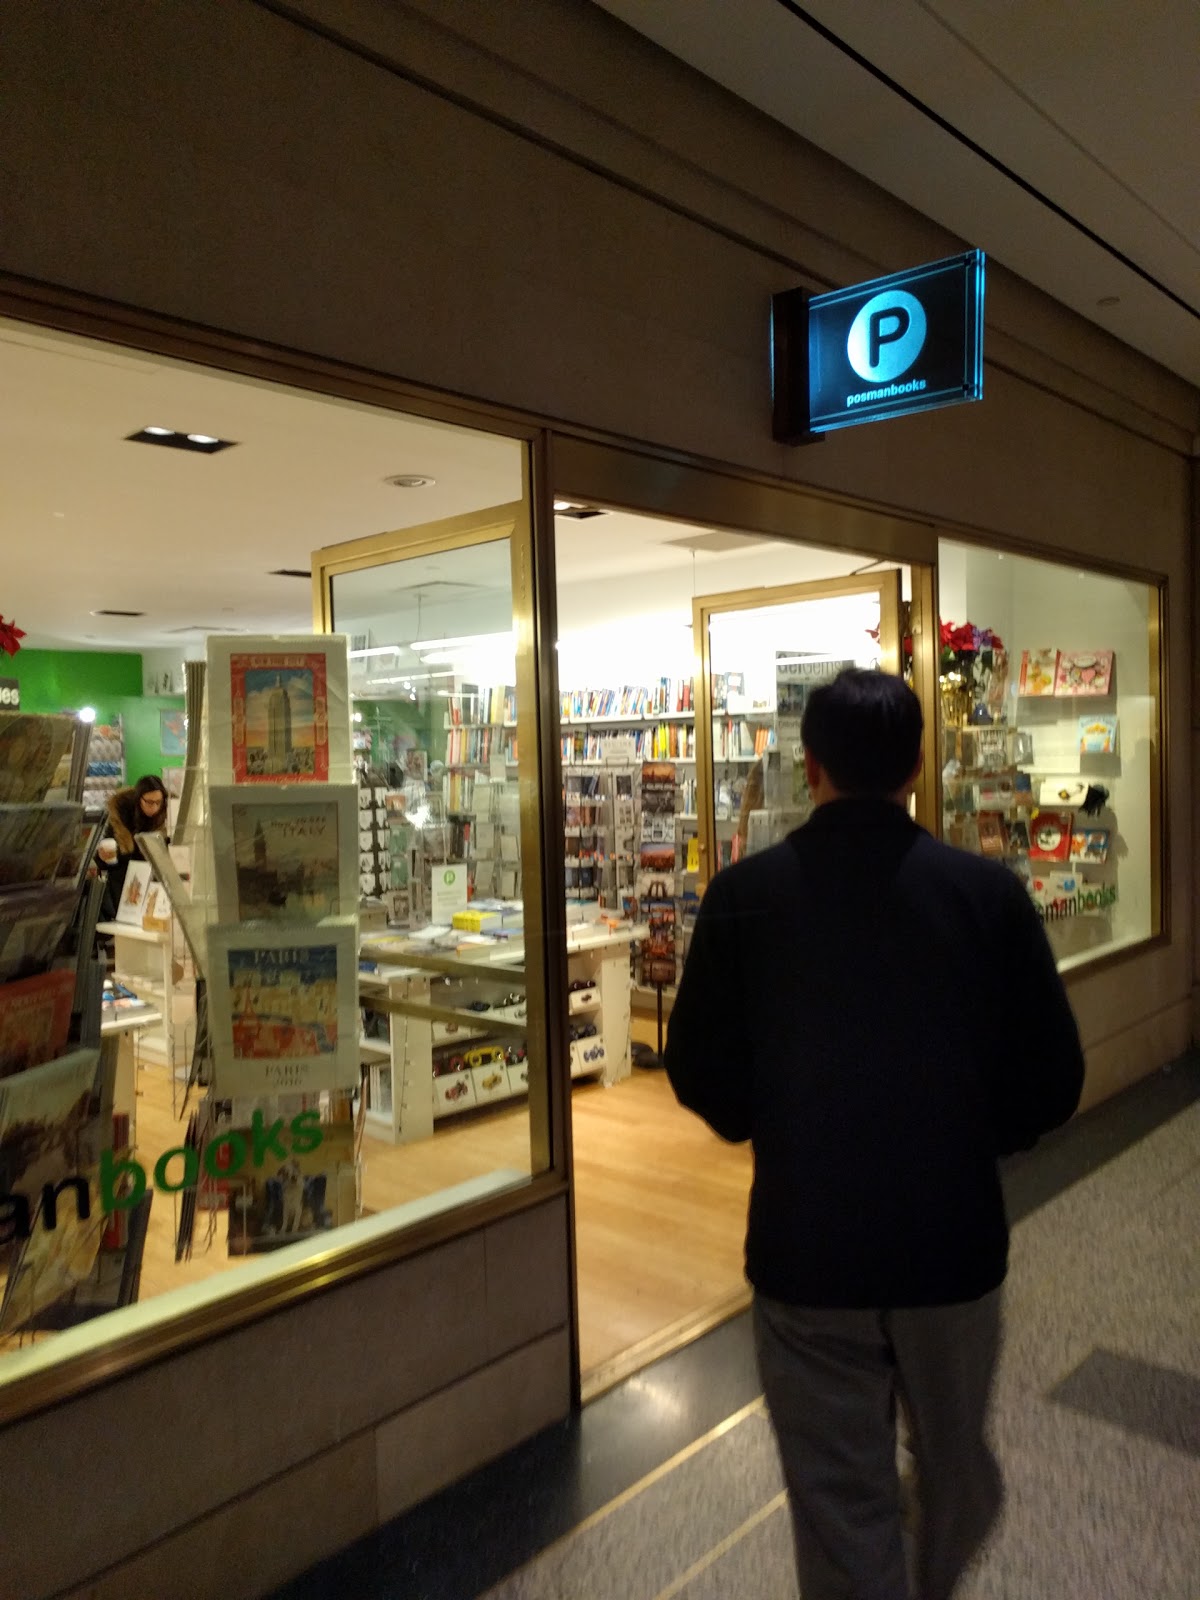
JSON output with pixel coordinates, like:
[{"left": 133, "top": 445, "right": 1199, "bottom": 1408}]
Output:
[{"left": 16, "top": 1066, "right": 750, "bottom": 1392}]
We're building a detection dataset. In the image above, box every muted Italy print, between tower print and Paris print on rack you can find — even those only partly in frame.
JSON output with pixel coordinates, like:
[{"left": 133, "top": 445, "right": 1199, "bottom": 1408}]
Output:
[{"left": 210, "top": 784, "right": 358, "bottom": 922}]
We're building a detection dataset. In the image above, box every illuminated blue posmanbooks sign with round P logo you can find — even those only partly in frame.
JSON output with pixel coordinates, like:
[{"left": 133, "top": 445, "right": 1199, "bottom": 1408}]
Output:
[{"left": 771, "top": 250, "right": 984, "bottom": 443}]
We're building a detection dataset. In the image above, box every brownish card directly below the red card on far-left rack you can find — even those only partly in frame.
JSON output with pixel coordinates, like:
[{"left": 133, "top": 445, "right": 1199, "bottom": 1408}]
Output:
[{"left": 0, "top": 1050, "right": 99, "bottom": 1202}]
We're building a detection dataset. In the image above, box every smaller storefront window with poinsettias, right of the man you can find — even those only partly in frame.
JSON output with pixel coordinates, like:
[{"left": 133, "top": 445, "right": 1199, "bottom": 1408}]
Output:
[{"left": 939, "top": 541, "right": 1162, "bottom": 970}]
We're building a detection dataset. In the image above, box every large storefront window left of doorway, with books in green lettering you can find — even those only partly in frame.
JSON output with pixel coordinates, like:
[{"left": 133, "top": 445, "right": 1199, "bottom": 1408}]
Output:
[{"left": 0, "top": 312, "right": 550, "bottom": 1414}]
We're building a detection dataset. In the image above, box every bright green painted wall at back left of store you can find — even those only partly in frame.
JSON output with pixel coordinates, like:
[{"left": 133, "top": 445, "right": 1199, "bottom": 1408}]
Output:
[{"left": 12, "top": 650, "right": 184, "bottom": 782}]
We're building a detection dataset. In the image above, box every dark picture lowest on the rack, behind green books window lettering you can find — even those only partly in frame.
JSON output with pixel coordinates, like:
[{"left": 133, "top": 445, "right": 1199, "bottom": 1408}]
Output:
[{"left": 227, "top": 1122, "right": 355, "bottom": 1256}]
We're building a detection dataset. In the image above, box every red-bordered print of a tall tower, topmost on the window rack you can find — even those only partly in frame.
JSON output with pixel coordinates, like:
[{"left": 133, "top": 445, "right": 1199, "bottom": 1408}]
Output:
[{"left": 208, "top": 634, "right": 352, "bottom": 784}]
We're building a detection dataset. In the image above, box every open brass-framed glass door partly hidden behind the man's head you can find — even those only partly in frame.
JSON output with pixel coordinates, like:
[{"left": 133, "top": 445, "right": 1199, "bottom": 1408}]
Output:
[{"left": 693, "top": 570, "right": 901, "bottom": 885}]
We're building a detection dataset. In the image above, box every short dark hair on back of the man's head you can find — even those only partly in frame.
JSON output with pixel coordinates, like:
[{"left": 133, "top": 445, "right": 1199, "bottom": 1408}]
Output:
[{"left": 800, "top": 667, "right": 923, "bottom": 795}]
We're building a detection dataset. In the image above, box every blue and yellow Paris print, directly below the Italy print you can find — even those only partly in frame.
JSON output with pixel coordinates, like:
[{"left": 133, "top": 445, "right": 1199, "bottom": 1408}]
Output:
[{"left": 208, "top": 917, "right": 358, "bottom": 1099}]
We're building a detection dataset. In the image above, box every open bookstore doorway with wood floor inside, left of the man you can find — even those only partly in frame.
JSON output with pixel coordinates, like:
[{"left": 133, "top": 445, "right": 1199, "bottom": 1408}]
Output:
[{"left": 555, "top": 501, "right": 931, "bottom": 1400}]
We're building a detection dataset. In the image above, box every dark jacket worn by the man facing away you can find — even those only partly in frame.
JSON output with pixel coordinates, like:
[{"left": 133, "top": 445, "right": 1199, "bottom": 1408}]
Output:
[{"left": 666, "top": 798, "right": 1083, "bottom": 1307}]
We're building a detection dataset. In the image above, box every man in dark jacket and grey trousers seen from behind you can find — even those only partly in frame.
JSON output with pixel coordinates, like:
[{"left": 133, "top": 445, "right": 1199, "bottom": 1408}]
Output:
[{"left": 666, "top": 670, "right": 1083, "bottom": 1600}]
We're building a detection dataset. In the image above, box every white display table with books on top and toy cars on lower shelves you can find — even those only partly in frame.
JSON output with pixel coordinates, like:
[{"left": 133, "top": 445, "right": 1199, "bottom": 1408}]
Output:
[{"left": 358, "top": 923, "right": 650, "bottom": 1144}]
